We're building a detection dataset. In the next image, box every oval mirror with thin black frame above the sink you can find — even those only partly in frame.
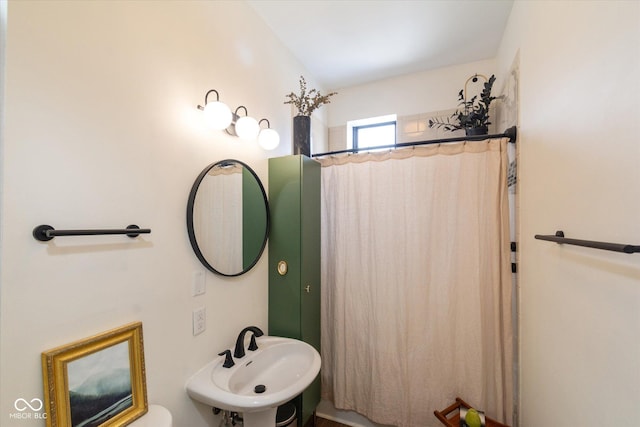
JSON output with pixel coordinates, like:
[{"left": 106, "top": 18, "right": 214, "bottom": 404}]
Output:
[{"left": 187, "top": 159, "right": 269, "bottom": 276}]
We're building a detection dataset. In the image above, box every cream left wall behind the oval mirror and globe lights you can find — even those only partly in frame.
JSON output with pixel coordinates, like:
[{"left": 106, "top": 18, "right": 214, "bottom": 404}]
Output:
[{"left": 0, "top": 1, "right": 314, "bottom": 427}]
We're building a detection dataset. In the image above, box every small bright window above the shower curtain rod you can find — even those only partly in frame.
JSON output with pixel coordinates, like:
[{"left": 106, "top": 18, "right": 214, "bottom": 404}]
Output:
[{"left": 347, "top": 114, "right": 396, "bottom": 150}]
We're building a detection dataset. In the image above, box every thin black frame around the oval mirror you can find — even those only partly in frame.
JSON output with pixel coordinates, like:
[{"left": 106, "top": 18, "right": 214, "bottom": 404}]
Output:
[{"left": 187, "top": 159, "right": 271, "bottom": 277}]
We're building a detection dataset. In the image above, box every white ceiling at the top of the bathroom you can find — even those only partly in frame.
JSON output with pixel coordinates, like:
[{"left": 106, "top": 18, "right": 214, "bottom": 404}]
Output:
[{"left": 247, "top": 0, "right": 513, "bottom": 89}]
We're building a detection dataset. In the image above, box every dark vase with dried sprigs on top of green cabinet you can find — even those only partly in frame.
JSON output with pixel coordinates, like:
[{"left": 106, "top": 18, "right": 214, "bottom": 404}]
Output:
[{"left": 284, "top": 76, "right": 337, "bottom": 156}]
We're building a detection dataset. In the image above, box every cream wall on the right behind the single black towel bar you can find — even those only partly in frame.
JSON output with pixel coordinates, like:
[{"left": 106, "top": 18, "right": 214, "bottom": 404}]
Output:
[{"left": 498, "top": 1, "right": 640, "bottom": 427}]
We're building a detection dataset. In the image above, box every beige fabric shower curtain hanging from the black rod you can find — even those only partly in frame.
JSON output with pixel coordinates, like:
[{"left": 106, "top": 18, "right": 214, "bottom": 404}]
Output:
[{"left": 321, "top": 138, "right": 513, "bottom": 427}]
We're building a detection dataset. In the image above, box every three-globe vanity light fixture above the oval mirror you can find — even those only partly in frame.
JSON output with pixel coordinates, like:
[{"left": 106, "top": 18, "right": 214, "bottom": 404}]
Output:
[{"left": 198, "top": 89, "right": 280, "bottom": 150}]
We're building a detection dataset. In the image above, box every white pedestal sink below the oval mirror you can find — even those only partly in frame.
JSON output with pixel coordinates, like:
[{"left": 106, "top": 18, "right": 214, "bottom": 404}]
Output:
[{"left": 186, "top": 336, "right": 320, "bottom": 427}]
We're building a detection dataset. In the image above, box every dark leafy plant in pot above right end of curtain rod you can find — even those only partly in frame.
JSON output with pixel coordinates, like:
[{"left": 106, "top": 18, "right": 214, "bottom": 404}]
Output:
[{"left": 429, "top": 74, "right": 496, "bottom": 136}]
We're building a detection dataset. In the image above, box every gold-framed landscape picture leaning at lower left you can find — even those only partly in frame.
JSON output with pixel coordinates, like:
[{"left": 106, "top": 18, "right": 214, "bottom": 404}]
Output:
[{"left": 42, "top": 322, "right": 148, "bottom": 427}]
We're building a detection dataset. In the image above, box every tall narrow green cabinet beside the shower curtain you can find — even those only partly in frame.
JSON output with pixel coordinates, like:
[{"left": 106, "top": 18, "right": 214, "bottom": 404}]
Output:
[{"left": 269, "top": 155, "right": 320, "bottom": 426}]
